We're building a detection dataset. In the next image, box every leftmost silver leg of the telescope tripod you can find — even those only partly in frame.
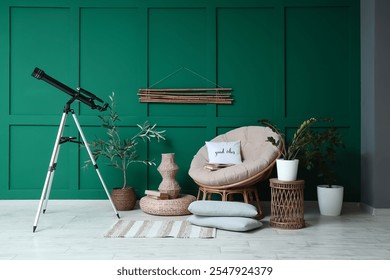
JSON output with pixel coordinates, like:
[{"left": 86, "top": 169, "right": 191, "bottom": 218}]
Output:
[{"left": 33, "top": 112, "right": 67, "bottom": 232}]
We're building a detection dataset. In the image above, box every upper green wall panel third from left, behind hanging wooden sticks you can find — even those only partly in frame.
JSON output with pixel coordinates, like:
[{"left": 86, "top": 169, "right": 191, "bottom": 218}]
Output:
[{"left": 148, "top": 8, "right": 210, "bottom": 116}]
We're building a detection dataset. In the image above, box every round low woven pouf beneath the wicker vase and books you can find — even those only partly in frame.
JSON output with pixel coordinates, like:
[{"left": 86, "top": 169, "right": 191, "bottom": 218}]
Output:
[{"left": 139, "top": 194, "right": 196, "bottom": 216}]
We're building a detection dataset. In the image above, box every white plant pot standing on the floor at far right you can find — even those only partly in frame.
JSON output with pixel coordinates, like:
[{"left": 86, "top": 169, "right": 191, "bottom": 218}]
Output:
[{"left": 317, "top": 185, "right": 344, "bottom": 216}]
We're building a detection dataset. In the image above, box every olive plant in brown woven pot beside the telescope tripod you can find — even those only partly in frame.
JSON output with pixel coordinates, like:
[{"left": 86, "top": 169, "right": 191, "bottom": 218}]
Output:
[{"left": 86, "top": 92, "right": 165, "bottom": 211}]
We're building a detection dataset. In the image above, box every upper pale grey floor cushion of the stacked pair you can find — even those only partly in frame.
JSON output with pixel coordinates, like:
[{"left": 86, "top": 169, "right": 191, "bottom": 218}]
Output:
[{"left": 188, "top": 200, "right": 258, "bottom": 218}]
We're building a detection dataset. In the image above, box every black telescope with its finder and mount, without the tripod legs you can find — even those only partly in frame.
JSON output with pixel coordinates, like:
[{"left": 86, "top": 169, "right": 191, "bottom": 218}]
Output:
[{"left": 31, "top": 67, "right": 108, "bottom": 112}]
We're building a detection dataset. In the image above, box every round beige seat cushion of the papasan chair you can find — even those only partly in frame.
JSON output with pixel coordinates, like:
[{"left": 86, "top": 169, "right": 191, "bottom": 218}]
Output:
[{"left": 188, "top": 126, "right": 279, "bottom": 186}]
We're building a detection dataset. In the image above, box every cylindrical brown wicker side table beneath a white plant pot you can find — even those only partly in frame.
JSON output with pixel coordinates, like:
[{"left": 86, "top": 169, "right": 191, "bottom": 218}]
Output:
[{"left": 270, "top": 179, "right": 305, "bottom": 229}]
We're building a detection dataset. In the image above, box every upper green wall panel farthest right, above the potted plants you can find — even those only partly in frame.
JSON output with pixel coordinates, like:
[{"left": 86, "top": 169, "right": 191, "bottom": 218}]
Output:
[{"left": 286, "top": 7, "right": 356, "bottom": 119}]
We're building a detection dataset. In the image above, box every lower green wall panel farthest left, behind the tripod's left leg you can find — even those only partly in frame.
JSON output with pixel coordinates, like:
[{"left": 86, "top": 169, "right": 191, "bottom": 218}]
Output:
[{"left": 9, "top": 126, "right": 78, "bottom": 197}]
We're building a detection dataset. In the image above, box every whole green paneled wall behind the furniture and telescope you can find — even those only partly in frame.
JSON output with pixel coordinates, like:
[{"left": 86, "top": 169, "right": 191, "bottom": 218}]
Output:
[{"left": 0, "top": 0, "right": 360, "bottom": 201}]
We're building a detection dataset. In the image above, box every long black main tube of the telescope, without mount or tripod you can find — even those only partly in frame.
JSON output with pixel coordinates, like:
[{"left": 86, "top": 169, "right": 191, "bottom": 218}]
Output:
[{"left": 31, "top": 67, "right": 107, "bottom": 111}]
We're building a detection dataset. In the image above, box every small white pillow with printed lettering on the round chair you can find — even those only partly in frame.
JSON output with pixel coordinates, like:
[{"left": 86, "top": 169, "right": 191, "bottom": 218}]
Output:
[{"left": 206, "top": 141, "right": 242, "bottom": 164}]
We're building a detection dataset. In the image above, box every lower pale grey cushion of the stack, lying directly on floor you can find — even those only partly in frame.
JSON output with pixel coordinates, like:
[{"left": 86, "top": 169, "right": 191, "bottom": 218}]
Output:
[{"left": 187, "top": 215, "right": 263, "bottom": 231}]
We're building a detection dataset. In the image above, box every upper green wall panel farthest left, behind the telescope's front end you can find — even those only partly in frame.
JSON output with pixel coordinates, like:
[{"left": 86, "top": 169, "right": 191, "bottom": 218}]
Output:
[{"left": 9, "top": 7, "right": 76, "bottom": 115}]
